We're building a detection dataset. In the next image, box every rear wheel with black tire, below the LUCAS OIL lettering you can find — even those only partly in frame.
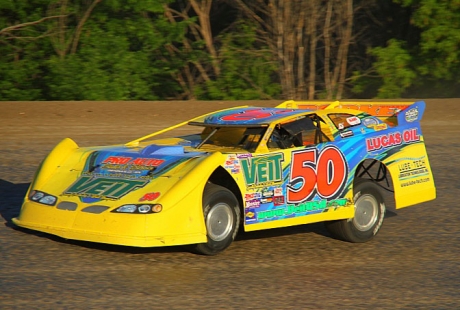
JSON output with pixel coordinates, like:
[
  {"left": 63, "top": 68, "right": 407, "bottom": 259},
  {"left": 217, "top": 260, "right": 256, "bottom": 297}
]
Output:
[{"left": 326, "top": 180, "right": 385, "bottom": 243}]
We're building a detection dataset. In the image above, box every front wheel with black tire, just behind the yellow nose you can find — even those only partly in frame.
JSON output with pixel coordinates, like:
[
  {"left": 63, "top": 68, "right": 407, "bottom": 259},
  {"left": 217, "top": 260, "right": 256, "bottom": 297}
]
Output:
[{"left": 192, "top": 183, "right": 240, "bottom": 255}]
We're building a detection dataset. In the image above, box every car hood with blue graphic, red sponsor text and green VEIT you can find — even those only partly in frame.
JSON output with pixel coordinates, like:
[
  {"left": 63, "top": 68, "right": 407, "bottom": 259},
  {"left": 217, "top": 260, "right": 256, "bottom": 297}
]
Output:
[{"left": 52, "top": 145, "right": 209, "bottom": 203}]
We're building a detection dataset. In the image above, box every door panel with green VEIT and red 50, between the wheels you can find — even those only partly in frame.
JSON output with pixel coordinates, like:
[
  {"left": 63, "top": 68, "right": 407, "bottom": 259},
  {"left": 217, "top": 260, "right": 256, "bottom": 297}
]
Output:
[{"left": 224, "top": 143, "right": 354, "bottom": 231}]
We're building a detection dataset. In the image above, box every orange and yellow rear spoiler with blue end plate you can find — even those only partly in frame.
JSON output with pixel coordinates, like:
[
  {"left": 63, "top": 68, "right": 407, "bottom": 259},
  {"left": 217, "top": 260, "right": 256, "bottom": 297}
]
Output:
[{"left": 277, "top": 100, "right": 425, "bottom": 124}]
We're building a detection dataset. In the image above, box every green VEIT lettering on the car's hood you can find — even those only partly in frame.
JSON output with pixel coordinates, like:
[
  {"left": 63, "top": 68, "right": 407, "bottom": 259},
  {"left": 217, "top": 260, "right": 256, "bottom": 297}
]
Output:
[{"left": 63, "top": 176, "right": 148, "bottom": 199}]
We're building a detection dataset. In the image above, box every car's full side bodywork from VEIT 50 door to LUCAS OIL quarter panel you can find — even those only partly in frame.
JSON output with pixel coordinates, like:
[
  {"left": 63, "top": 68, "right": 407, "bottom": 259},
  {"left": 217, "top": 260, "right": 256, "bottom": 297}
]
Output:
[{"left": 229, "top": 103, "right": 436, "bottom": 231}]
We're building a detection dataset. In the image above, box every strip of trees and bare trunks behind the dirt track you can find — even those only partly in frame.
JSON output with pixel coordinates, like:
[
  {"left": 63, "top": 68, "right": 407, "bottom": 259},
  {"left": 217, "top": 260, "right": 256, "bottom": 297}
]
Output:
[{"left": 0, "top": 0, "right": 460, "bottom": 100}]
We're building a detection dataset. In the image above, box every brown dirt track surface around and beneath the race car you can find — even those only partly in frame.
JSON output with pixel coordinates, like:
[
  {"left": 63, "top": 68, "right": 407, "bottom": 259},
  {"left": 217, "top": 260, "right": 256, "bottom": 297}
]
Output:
[{"left": 0, "top": 99, "right": 460, "bottom": 309}]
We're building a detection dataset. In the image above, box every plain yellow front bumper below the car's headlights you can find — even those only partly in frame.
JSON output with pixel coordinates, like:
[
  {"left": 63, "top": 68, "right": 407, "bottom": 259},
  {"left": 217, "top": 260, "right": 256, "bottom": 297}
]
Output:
[{"left": 13, "top": 201, "right": 207, "bottom": 247}]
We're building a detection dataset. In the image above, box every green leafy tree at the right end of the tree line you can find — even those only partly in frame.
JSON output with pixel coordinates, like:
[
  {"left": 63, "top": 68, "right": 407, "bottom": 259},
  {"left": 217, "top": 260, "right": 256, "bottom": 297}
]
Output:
[{"left": 362, "top": 0, "right": 460, "bottom": 98}]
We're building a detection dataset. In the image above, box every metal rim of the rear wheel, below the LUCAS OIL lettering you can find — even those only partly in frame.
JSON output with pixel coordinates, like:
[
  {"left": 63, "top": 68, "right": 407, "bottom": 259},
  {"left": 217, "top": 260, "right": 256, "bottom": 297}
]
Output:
[{"left": 353, "top": 194, "right": 379, "bottom": 231}]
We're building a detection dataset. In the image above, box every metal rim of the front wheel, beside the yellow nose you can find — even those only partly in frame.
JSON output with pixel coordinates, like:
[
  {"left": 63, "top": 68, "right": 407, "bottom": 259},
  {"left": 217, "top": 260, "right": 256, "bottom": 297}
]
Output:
[{"left": 206, "top": 203, "right": 233, "bottom": 241}]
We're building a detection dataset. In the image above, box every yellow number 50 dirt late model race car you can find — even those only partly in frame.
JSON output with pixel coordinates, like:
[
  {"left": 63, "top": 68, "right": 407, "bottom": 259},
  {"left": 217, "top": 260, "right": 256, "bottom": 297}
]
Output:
[{"left": 13, "top": 101, "right": 436, "bottom": 255}]
